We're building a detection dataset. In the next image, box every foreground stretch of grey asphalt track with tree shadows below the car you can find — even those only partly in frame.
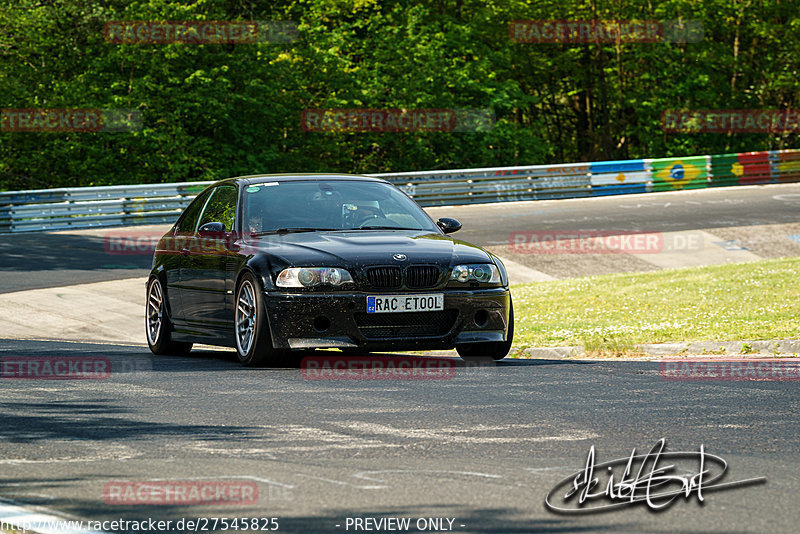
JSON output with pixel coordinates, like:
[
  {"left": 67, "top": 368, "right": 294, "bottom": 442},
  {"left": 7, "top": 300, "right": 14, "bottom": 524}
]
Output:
[{"left": 0, "top": 340, "right": 800, "bottom": 532}]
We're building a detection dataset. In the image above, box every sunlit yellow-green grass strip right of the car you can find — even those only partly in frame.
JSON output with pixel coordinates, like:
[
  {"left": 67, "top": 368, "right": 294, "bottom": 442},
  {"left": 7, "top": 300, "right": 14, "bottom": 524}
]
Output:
[{"left": 511, "top": 257, "right": 800, "bottom": 353}]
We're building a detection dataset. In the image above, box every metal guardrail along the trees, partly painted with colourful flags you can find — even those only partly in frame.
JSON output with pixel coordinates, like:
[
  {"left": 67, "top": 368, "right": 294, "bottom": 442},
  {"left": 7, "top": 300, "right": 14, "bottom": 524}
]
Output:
[{"left": 0, "top": 150, "right": 800, "bottom": 233}]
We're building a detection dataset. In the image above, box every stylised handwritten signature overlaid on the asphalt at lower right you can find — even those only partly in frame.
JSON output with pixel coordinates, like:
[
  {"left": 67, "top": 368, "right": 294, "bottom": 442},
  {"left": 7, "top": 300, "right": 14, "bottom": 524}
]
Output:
[{"left": 545, "top": 438, "right": 767, "bottom": 515}]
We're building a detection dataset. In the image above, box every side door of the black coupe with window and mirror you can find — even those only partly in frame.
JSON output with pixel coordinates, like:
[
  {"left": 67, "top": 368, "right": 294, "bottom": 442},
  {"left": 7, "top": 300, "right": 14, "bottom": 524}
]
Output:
[{"left": 180, "top": 184, "right": 237, "bottom": 335}]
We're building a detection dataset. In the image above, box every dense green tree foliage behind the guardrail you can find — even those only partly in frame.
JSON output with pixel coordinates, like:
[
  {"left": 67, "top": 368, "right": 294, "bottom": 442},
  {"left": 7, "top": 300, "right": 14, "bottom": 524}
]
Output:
[{"left": 0, "top": 0, "right": 800, "bottom": 189}]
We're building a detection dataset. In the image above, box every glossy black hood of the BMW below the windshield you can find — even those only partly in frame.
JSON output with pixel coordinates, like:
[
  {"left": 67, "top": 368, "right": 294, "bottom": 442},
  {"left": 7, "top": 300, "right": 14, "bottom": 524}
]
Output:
[{"left": 243, "top": 230, "right": 491, "bottom": 267}]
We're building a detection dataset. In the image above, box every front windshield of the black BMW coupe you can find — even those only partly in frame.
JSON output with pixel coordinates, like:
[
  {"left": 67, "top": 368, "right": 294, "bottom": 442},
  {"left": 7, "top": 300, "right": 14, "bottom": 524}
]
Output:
[{"left": 243, "top": 180, "right": 436, "bottom": 233}]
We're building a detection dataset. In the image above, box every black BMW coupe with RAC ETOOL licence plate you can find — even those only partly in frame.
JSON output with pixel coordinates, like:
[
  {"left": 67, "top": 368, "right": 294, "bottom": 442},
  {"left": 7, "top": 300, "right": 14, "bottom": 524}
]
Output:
[{"left": 145, "top": 174, "right": 514, "bottom": 365}]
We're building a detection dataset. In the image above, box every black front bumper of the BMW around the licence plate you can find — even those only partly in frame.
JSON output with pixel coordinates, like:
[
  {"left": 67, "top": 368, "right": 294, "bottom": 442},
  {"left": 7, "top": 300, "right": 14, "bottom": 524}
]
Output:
[{"left": 265, "top": 288, "right": 511, "bottom": 351}]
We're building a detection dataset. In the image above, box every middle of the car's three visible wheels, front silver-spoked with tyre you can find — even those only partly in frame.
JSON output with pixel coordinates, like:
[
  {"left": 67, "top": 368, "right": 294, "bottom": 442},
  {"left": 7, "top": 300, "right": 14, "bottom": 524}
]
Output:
[{"left": 233, "top": 272, "right": 284, "bottom": 367}]
